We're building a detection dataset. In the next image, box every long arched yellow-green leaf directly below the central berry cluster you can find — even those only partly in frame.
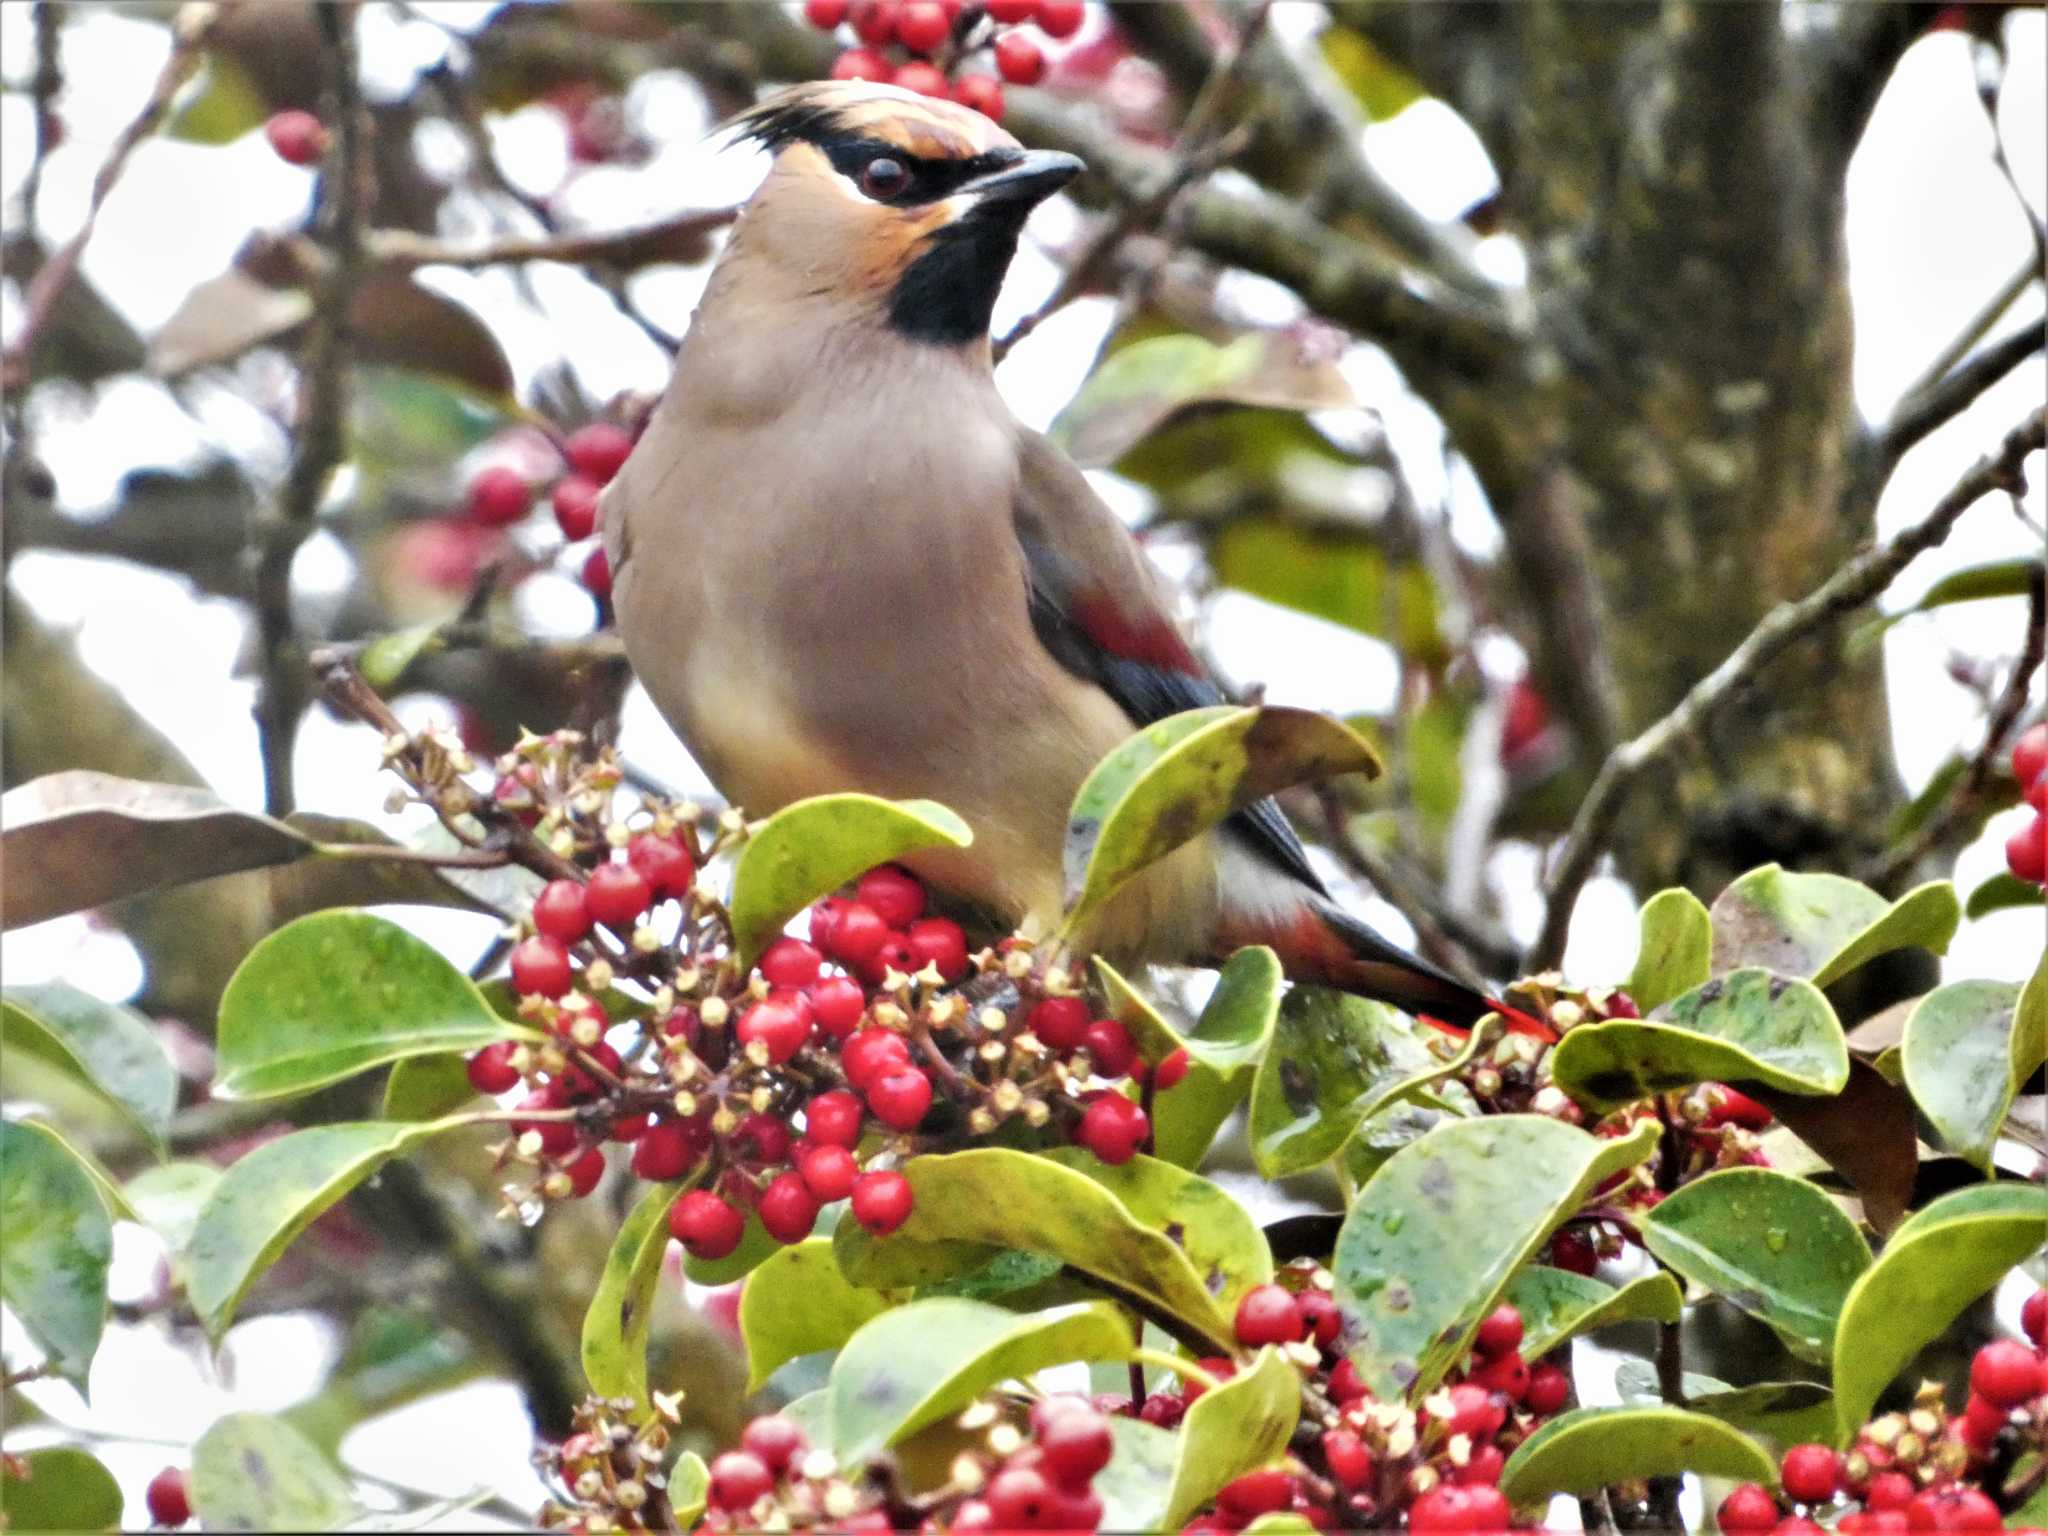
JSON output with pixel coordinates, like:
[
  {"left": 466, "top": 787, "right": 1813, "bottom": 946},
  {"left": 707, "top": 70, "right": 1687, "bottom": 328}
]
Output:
[{"left": 831, "top": 1147, "right": 1235, "bottom": 1350}]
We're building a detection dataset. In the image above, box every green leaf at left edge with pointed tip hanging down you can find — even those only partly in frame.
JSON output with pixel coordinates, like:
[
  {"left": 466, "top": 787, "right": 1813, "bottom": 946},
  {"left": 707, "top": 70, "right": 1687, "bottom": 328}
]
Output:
[{"left": 0, "top": 1120, "right": 115, "bottom": 1393}]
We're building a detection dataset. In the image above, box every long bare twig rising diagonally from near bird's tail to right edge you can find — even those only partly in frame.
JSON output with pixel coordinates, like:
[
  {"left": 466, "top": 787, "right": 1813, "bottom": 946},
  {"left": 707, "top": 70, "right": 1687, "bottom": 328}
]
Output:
[{"left": 1528, "top": 410, "right": 2048, "bottom": 971}]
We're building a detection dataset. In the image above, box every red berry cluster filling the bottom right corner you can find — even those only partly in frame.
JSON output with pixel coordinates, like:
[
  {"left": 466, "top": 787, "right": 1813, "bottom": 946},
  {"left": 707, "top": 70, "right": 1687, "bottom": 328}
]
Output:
[{"left": 1718, "top": 1290, "right": 2048, "bottom": 1536}]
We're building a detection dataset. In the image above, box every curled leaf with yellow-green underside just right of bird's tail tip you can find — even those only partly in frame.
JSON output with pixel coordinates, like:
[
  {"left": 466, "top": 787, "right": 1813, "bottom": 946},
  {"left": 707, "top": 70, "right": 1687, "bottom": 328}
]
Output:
[{"left": 1550, "top": 969, "right": 1849, "bottom": 1110}]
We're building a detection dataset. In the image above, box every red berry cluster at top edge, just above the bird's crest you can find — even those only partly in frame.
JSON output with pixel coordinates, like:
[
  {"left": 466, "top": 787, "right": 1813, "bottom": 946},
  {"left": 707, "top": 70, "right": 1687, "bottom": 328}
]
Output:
[{"left": 803, "top": 0, "right": 1087, "bottom": 119}]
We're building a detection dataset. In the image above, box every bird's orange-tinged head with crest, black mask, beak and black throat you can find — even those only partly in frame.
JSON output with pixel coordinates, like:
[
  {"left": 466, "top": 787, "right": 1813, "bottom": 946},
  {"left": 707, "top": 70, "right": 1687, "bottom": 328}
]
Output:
[{"left": 739, "top": 82, "right": 1081, "bottom": 346}]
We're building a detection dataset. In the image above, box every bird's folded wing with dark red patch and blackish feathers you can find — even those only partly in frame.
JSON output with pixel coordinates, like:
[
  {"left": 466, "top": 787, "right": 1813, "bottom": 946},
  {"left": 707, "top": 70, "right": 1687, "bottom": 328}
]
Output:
[{"left": 1016, "top": 432, "right": 1323, "bottom": 893}]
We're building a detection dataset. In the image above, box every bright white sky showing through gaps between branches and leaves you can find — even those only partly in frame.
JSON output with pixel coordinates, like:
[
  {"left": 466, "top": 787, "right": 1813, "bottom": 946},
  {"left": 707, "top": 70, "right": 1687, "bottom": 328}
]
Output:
[{"left": 0, "top": 6, "right": 2048, "bottom": 1518}]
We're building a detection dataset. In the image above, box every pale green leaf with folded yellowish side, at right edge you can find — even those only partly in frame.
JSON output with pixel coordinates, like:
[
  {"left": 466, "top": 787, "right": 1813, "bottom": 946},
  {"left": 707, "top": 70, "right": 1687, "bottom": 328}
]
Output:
[{"left": 1898, "top": 969, "right": 2048, "bottom": 1174}]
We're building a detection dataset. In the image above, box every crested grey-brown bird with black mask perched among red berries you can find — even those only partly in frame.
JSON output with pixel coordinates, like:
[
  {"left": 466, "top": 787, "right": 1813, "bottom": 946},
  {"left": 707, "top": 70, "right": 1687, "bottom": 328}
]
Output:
[{"left": 600, "top": 82, "right": 1520, "bottom": 1028}]
